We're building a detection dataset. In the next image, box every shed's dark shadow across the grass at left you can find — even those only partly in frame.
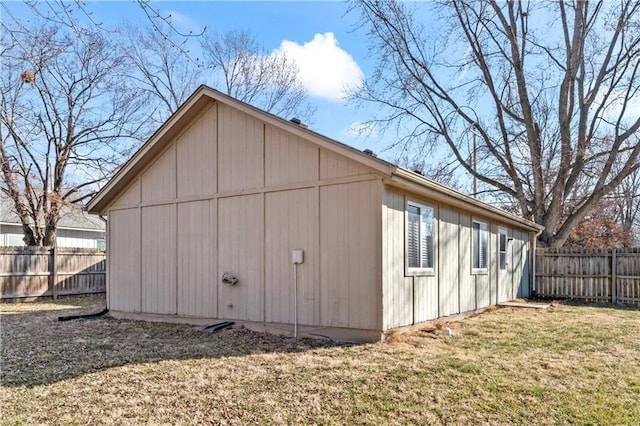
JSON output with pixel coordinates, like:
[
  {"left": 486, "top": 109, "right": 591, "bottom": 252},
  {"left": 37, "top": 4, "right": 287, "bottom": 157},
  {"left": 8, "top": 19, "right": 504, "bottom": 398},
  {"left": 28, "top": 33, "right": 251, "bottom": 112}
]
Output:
[{"left": 0, "top": 303, "right": 348, "bottom": 387}]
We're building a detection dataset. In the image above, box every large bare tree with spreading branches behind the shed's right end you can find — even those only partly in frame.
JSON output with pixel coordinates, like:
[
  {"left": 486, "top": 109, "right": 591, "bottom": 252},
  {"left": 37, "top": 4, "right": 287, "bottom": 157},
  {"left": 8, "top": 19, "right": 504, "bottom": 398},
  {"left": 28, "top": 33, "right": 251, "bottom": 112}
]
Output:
[{"left": 353, "top": 0, "right": 640, "bottom": 246}]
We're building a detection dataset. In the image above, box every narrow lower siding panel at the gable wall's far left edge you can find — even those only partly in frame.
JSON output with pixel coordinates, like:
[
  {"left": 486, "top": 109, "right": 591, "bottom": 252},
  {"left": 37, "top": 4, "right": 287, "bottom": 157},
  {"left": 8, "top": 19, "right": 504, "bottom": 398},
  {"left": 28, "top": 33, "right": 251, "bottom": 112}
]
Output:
[{"left": 107, "top": 208, "right": 140, "bottom": 312}]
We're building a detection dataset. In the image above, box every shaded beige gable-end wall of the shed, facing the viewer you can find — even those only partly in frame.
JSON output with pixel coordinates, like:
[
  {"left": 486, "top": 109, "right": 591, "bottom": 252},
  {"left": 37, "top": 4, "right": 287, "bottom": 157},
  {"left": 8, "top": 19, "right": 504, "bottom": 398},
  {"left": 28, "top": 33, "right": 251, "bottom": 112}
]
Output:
[{"left": 108, "top": 103, "right": 383, "bottom": 330}]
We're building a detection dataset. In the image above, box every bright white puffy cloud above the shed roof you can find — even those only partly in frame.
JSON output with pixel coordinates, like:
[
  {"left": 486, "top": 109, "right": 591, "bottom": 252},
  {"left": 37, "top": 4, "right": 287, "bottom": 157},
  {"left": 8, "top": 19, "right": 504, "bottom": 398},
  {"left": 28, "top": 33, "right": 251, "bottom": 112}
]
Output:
[{"left": 276, "top": 33, "right": 364, "bottom": 101}]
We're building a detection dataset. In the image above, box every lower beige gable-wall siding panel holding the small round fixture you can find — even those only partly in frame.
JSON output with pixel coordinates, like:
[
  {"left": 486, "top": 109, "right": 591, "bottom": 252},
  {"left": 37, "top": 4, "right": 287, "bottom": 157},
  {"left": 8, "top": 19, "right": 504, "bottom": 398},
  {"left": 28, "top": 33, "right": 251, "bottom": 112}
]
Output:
[{"left": 217, "top": 195, "right": 264, "bottom": 321}]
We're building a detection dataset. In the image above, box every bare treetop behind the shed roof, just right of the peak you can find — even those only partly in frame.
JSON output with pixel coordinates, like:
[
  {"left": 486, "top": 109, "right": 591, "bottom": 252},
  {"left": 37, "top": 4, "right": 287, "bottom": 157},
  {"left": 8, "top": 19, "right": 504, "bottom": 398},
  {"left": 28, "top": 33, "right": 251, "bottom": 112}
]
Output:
[{"left": 201, "top": 31, "right": 314, "bottom": 120}]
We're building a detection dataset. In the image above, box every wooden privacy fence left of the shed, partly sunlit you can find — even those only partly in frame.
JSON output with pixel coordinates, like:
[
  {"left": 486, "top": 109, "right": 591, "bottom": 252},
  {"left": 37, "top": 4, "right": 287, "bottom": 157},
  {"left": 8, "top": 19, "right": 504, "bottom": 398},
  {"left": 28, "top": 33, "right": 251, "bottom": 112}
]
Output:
[{"left": 0, "top": 247, "right": 106, "bottom": 299}]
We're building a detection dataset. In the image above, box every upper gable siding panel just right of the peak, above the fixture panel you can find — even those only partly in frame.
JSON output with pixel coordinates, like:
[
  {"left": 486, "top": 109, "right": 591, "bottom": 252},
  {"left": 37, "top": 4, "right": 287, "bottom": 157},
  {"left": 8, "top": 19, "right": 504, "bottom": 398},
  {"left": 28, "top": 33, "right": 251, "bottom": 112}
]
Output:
[{"left": 218, "top": 105, "right": 264, "bottom": 192}]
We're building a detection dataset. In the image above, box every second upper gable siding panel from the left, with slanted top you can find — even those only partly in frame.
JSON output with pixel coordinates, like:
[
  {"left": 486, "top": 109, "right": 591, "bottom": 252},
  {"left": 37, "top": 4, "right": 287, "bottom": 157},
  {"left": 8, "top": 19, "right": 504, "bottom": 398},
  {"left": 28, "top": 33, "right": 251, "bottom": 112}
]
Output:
[{"left": 141, "top": 144, "right": 176, "bottom": 203}]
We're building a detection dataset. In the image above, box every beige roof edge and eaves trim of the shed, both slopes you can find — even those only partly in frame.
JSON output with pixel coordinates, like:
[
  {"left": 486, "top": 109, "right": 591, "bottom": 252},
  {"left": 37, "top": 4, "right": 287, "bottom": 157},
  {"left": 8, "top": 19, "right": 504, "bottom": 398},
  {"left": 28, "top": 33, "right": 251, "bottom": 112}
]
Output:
[{"left": 88, "top": 85, "right": 543, "bottom": 232}]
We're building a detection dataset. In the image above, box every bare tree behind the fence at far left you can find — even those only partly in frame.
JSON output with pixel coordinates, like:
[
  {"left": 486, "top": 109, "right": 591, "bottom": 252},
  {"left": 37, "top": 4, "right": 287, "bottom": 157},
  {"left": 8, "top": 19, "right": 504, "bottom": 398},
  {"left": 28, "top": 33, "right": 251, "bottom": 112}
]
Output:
[{"left": 0, "top": 20, "right": 144, "bottom": 246}]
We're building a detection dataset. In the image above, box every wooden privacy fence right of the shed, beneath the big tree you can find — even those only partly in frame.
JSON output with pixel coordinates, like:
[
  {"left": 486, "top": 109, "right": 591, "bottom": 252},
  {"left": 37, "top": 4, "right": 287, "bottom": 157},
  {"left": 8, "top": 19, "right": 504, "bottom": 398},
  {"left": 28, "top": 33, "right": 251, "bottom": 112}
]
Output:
[{"left": 536, "top": 248, "right": 640, "bottom": 304}]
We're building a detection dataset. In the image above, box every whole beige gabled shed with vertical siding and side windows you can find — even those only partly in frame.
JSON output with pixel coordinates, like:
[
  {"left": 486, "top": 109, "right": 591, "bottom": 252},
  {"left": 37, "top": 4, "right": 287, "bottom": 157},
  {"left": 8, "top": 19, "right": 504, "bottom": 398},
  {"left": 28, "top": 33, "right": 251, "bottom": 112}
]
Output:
[{"left": 88, "top": 86, "right": 541, "bottom": 340}]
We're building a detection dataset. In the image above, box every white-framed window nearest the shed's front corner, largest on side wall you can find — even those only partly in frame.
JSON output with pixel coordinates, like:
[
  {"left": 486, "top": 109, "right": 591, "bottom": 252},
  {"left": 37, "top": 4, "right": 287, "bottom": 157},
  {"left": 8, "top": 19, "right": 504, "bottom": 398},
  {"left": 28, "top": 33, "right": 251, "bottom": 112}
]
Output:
[{"left": 407, "top": 201, "right": 435, "bottom": 273}]
